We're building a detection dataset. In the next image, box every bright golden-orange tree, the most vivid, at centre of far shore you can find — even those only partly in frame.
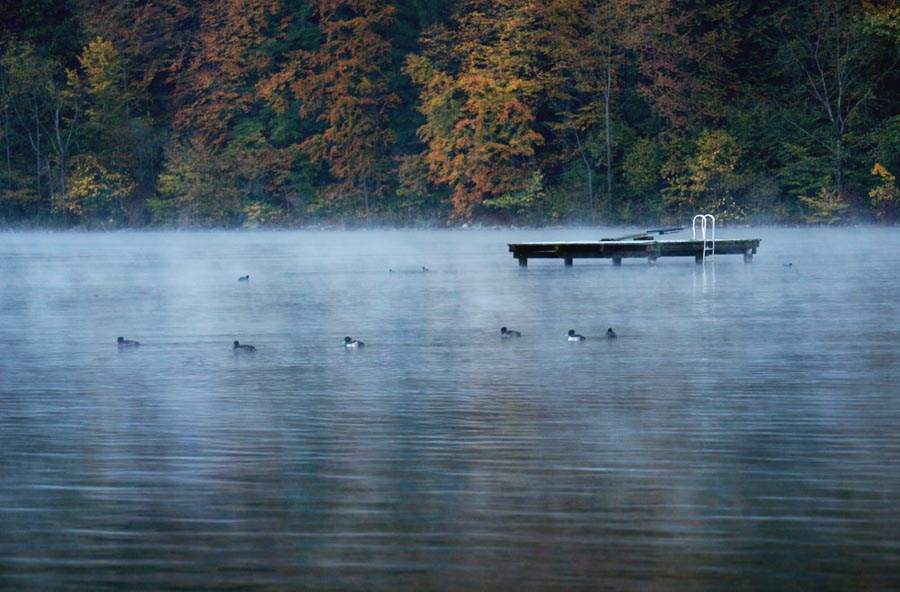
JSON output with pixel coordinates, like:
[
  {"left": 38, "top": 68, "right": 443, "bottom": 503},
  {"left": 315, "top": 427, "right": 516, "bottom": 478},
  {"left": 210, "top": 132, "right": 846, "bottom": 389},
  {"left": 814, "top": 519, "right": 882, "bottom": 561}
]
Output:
[{"left": 406, "top": 0, "right": 544, "bottom": 218}]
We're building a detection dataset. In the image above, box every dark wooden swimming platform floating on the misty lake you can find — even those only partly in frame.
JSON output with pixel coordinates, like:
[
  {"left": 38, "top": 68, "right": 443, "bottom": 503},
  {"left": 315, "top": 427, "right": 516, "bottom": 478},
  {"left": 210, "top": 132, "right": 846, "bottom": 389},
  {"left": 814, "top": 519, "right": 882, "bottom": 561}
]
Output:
[{"left": 509, "top": 228, "right": 761, "bottom": 267}]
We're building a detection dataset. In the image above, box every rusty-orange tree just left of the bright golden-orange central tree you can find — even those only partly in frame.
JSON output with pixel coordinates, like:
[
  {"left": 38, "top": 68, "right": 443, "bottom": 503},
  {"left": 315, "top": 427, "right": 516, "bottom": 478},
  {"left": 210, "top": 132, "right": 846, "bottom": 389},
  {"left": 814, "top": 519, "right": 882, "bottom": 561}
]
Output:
[{"left": 260, "top": 0, "right": 397, "bottom": 216}]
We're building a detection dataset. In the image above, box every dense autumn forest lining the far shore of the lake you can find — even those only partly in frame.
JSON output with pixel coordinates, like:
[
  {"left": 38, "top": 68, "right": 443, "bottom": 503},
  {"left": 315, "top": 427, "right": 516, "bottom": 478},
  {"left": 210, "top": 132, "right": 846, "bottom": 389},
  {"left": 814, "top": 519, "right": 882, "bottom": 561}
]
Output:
[{"left": 0, "top": 0, "right": 900, "bottom": 228}]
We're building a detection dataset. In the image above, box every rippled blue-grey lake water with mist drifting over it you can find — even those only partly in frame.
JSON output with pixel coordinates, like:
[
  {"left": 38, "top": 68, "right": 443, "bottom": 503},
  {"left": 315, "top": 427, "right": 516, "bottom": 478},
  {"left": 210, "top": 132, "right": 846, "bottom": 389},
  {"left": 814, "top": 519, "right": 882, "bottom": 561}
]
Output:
[{"left": 0, "top": 228, "right": 900, "bottom": 591}]
